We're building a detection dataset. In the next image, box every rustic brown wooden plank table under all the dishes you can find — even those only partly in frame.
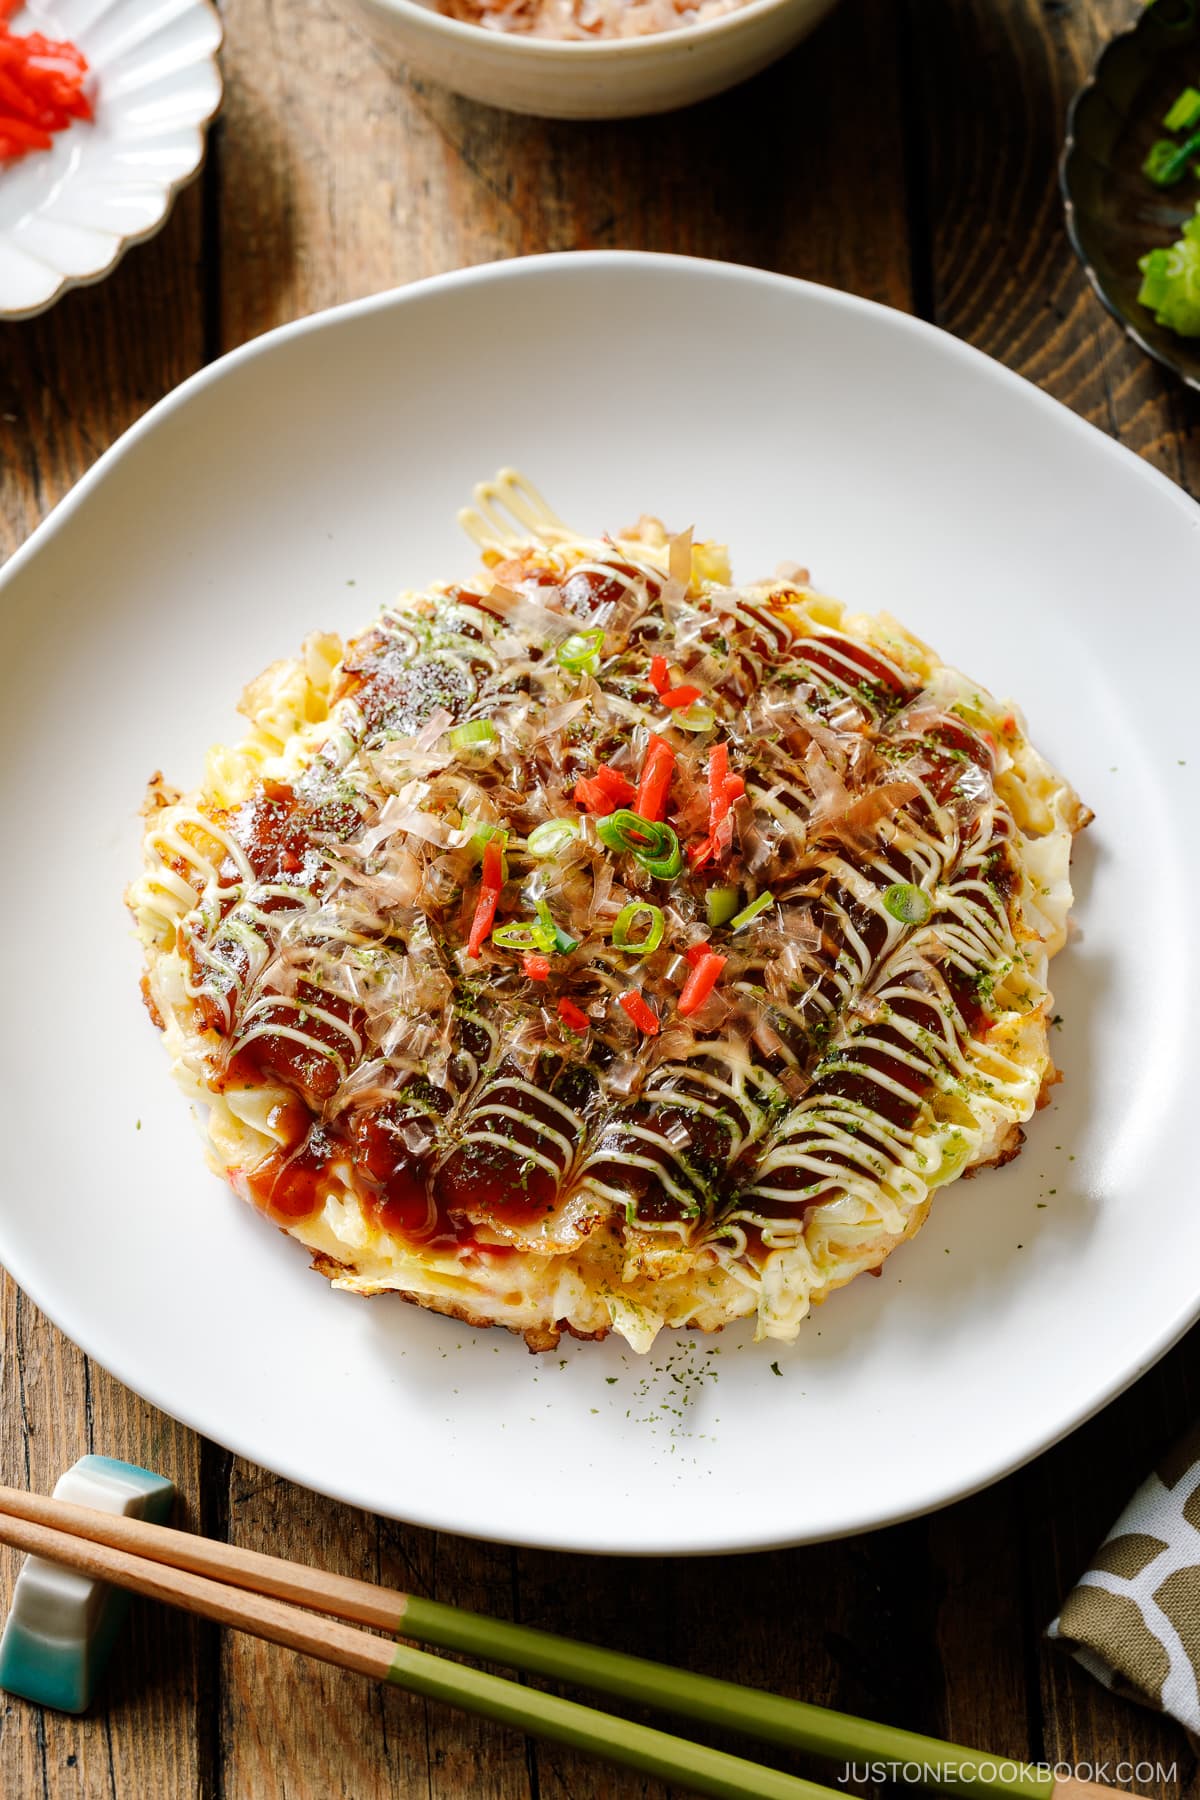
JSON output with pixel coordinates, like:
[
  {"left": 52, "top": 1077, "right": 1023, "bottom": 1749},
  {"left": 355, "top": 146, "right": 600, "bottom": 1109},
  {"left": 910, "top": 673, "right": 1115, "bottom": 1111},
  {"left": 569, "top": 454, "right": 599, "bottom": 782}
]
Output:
[{"left": 0, "top": 0, "right": 1200, "bottom": 1800}]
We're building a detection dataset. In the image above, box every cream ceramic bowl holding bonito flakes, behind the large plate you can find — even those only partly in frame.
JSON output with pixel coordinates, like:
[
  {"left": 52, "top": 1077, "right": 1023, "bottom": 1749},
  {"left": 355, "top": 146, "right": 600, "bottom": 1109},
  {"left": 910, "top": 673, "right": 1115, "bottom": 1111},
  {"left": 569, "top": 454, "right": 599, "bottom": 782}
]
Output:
[{"left": 345, "top": 0, "right": 835, "bottom": 119}]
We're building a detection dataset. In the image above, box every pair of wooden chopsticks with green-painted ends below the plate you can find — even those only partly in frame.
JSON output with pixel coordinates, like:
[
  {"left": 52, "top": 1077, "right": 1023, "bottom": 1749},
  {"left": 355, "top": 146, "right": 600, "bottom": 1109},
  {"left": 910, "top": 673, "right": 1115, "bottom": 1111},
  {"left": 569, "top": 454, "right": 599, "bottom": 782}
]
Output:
[{"left": 0, "top": 1487, "right": 1072, "bottom": 1800}]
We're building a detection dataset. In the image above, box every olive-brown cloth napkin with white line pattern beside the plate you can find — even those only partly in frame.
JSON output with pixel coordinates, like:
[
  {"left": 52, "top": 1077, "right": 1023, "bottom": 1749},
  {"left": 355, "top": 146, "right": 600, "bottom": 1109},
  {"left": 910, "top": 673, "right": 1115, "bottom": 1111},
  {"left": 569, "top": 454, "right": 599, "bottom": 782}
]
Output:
[{"left": 1047, "top": 1427, "right": 1200, "bottom": 1732}]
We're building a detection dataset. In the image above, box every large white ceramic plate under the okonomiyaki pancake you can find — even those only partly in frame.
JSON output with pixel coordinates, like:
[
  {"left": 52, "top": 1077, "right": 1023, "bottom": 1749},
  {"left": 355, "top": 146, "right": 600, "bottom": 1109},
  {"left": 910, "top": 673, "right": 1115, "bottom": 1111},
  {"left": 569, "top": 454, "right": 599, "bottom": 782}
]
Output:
[{"left": 0, "top": 254, "right": 1200, "bottom": 1552}]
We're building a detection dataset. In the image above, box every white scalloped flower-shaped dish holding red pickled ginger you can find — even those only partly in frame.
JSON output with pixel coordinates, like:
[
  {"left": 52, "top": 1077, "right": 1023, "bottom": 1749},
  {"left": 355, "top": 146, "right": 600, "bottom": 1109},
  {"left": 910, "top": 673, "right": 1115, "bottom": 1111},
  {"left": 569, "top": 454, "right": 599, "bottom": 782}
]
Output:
[{"left": 0, "top": 0, "right": 221, "bottom": 319}]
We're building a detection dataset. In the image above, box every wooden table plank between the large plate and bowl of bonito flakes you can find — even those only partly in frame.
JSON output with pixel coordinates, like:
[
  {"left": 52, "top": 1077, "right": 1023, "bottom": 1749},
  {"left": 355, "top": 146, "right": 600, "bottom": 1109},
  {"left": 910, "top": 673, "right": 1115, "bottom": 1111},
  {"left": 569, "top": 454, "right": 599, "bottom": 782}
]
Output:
[{"left": 218, "top": 0, "right": 910, "bottom": 347}]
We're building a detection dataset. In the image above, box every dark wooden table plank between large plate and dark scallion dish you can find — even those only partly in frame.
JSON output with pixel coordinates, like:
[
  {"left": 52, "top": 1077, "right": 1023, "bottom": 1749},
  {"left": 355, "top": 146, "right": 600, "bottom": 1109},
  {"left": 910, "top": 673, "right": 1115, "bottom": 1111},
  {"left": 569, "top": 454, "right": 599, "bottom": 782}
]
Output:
[{"left": 909, "top": 0, "right": 1200, "bottom": 493}]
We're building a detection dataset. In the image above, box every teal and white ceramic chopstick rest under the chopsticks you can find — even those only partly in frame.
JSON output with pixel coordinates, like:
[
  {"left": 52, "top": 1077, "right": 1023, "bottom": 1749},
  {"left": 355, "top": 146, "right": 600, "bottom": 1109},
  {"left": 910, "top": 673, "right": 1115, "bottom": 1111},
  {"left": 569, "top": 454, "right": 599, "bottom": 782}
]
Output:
[{"left": 0, "top": 1456, "right": 175, "bottom": 1712}]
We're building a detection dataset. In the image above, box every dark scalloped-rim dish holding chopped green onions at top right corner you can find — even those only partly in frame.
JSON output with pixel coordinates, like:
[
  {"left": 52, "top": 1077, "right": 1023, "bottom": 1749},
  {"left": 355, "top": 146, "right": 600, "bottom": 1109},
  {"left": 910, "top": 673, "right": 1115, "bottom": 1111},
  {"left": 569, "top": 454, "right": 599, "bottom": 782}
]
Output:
[{"left": 1060, "top": 0, "right": 1200, "bottom": 389}]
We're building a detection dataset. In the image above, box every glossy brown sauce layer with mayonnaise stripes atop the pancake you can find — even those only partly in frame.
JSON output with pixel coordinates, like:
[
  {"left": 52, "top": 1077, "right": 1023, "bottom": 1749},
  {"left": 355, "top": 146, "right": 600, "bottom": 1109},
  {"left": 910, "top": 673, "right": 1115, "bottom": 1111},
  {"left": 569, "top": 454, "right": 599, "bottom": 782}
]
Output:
[{"left": 138, "top": 544, "right": 1018, "bottom": 1271}]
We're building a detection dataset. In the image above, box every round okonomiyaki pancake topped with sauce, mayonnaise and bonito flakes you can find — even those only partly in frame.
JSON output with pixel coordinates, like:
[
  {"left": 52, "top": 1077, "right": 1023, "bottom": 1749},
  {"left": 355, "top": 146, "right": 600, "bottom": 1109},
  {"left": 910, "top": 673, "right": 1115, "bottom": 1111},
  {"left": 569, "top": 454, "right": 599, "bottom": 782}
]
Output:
[{"left": 130, "top": 472, "right": 1088, "bottom": 1350}]
